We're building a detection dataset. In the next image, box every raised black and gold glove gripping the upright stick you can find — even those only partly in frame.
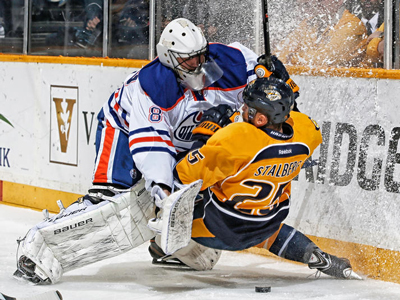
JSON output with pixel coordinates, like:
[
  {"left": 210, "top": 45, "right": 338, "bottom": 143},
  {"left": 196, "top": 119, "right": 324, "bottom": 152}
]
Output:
[{"left": 254, "top": 55, "right": 299, "bottom": 95}]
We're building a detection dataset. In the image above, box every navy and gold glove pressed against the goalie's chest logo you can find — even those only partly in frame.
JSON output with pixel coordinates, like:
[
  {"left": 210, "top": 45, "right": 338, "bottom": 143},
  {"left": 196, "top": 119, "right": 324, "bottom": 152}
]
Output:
[{"left": 192, "top": 104, "right": 240, "bottom": 143}]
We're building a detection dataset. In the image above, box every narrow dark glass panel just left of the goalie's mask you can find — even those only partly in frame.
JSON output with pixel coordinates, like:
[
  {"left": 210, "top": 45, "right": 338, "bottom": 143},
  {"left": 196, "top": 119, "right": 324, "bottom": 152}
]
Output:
[{"left": 108, "top": 0, "right": 150, "bottom": 59}]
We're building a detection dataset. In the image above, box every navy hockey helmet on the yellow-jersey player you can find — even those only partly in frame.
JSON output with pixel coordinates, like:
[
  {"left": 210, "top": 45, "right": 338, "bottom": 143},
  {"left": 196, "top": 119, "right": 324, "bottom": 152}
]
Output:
[{"left": 243, "top": 77, "right": 294, "bottom": 125}]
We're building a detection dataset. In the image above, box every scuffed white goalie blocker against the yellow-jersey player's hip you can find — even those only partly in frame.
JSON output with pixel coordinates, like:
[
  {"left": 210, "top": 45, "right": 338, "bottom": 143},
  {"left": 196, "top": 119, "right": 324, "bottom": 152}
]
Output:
[{"left": 149, "top": 180, "right": 203, "bottom": 255}]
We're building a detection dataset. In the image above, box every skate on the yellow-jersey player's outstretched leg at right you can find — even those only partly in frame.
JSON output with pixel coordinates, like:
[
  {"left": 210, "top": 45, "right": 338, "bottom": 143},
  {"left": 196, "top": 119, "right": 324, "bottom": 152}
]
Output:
[{"left": 308, "top": 248, "right": 362, "bottom": 279}]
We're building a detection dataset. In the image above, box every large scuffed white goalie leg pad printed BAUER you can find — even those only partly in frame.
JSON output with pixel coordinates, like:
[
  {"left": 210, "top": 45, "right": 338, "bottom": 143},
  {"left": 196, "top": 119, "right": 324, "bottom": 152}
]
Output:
[{"left": 21, "top": 180, "right": 155, "bottom": 283}]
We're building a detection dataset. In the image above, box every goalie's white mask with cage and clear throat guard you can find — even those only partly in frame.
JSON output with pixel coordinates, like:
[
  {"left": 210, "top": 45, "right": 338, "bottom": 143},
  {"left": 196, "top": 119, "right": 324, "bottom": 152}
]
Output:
[{"left": 157, "top": 18, "right": 223, "bottom": 91}]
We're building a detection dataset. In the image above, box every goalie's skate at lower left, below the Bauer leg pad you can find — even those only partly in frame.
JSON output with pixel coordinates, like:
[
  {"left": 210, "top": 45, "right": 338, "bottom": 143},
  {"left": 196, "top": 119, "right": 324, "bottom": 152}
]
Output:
[{"left": 13, "top": 255, "right": 51, "bottom": 284}]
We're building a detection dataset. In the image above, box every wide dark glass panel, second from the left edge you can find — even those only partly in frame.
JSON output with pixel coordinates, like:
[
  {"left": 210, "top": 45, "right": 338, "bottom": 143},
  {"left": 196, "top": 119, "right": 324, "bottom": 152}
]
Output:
[{"left": 28, "top": 0, "right": 103, "bottom": 57}]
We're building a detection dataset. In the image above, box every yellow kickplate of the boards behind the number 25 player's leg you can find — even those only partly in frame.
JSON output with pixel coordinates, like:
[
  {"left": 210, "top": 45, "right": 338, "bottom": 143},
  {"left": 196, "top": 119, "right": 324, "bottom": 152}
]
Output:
[{"left": 245, "top": 236, "right": 400, "bottom": 283}]
